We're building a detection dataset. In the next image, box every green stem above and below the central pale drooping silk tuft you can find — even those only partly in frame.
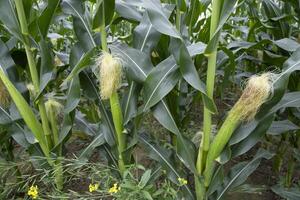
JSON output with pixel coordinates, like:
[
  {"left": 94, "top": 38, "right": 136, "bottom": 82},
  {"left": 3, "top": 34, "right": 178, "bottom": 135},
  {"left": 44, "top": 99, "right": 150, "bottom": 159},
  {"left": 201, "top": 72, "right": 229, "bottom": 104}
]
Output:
[{"left": 100, "top": 2, "right": 126, "bottom": 175}]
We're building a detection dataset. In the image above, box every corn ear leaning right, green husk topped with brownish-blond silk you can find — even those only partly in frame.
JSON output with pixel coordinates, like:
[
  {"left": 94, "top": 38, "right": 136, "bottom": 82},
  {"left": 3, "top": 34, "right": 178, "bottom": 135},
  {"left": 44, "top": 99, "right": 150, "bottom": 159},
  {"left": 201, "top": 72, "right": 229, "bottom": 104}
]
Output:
[{"left": 204, "top": 73, "right": 272, "bottom": 187}]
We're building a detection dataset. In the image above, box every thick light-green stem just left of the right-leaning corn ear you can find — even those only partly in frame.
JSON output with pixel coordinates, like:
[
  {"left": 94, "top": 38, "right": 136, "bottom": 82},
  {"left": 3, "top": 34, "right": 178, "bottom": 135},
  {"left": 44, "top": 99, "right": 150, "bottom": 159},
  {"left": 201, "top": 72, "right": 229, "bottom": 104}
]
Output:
[{"left": 197, "top": 0, "right": 222, "bottom": 175}]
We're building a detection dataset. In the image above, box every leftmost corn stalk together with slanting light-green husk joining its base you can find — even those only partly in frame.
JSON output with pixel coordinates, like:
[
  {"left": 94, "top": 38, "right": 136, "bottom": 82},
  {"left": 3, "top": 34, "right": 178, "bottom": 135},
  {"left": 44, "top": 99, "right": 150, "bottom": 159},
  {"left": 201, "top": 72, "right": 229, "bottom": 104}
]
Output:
[{"left": 11, "top": 0, "right": 63, "bottom": 190}]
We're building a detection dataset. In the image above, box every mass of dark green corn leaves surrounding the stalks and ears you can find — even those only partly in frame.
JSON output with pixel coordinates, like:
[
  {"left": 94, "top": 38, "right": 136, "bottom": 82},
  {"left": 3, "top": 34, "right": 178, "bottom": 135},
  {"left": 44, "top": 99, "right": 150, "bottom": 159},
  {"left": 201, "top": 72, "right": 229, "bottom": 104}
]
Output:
[{"left": 0, "top": 0, "right": 300, "bottom": 199}]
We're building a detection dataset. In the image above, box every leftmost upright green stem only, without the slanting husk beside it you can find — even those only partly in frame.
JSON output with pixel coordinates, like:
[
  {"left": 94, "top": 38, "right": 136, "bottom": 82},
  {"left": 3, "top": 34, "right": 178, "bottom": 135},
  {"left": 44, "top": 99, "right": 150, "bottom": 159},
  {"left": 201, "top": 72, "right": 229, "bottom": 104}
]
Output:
[{"left": 15, "top": 0, "right": 52, "bottom": 151}]
